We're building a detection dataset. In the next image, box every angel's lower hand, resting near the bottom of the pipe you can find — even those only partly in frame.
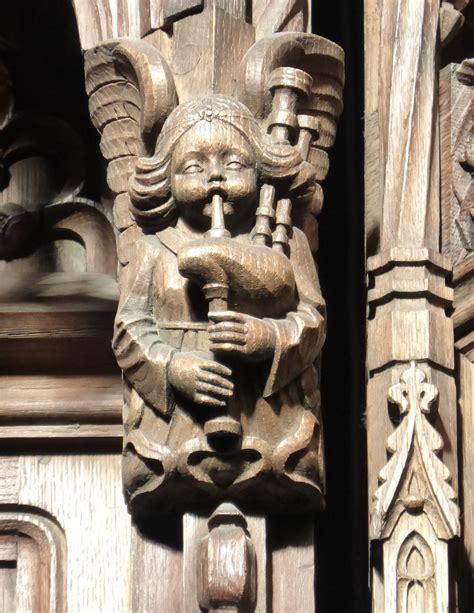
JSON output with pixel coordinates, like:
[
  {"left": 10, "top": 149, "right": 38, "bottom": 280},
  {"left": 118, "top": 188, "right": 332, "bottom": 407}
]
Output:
[{"left": 168, "top": 351, "right": 234, "bottom": 407}]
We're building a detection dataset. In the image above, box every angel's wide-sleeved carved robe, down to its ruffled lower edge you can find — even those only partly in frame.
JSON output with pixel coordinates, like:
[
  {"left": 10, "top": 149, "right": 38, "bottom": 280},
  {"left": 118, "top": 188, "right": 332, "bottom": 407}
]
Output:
[{"left": 113, "top": 222, "right": 325, "bottom": 512}]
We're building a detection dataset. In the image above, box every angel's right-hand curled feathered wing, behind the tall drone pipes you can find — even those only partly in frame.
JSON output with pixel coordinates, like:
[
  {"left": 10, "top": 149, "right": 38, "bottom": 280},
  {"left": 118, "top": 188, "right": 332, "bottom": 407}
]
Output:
[{"left": 237, "top": 32, "right": 344, "bottom": 251}]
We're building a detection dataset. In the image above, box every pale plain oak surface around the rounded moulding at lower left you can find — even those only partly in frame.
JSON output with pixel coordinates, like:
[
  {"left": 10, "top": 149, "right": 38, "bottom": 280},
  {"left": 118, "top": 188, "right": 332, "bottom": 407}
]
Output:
[{"left": 19, "top": 454, "right": 130, "bottom": 613}]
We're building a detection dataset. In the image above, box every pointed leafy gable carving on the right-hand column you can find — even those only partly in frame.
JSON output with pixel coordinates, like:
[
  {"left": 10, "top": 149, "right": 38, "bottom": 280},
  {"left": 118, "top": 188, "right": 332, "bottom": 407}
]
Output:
[{"left": 371, "top": 362, "right": 460, "bottom": 539}]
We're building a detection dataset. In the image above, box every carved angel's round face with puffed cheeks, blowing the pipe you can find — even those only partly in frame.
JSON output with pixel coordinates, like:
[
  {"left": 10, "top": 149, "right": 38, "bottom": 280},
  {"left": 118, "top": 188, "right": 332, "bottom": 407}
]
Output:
[{"left": 171, "top": 119, "right": 257, "bottom": 230}]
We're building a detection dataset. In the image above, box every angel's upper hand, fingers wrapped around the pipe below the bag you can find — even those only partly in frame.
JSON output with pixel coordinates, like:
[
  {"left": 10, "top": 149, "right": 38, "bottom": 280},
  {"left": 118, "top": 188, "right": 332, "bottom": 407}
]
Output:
[{"left": 209, "top": 311, "right": 276, "bottom": 362}]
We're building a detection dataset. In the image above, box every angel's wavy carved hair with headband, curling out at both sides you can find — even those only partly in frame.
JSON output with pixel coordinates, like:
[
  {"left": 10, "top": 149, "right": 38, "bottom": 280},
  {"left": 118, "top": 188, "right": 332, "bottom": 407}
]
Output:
[{"left": 130, "top": 95, "right": 304, "bottom": 231}]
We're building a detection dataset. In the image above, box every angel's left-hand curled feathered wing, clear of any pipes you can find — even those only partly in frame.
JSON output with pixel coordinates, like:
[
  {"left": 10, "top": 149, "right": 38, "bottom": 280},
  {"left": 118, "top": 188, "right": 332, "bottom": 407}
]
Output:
[{"left": 85, "top": 39, "right": 178, "bottom": 264}]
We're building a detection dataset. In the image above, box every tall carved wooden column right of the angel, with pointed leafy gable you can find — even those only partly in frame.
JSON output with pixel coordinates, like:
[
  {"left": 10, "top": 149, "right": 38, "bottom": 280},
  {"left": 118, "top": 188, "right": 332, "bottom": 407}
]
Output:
[{"left": 367, "top": 0, "right": 459, "bottom": 613}]
